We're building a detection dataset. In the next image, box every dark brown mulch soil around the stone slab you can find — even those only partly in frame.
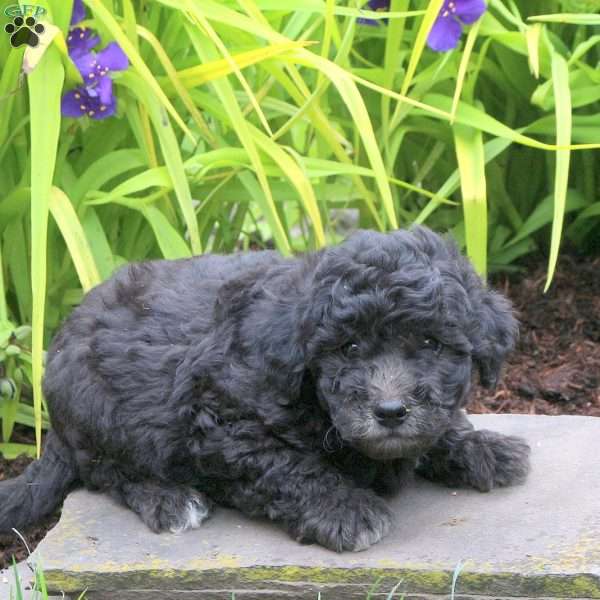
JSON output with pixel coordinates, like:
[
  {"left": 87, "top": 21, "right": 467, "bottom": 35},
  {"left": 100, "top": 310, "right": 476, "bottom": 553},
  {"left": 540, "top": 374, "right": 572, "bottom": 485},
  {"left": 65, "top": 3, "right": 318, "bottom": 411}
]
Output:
[{"left": 0, "top": 255, "right": 600, "bottom": 569}]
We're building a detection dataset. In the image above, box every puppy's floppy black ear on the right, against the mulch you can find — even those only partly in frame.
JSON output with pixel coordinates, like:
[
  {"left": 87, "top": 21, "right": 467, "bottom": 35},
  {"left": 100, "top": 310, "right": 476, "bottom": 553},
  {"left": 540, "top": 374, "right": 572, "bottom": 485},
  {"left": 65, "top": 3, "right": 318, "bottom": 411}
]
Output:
[{"left": 471, "top": 288, "right": 518, "bottom": 389}]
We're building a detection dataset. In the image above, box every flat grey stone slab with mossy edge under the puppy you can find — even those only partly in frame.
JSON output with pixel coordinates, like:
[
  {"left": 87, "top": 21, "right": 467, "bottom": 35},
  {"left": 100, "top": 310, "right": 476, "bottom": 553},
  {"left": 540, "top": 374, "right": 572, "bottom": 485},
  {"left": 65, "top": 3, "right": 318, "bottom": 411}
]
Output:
[{"left": 35, "top": 415, "right": 600, "bottom": 600}]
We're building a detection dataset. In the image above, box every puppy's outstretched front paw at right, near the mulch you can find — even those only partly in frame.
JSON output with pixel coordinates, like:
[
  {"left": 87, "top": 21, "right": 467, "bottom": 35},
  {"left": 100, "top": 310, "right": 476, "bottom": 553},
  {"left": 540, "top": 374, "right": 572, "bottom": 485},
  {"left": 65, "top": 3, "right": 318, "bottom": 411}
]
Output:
[{"left": 451, "top": 429, "right": 531, "bottom": 492}]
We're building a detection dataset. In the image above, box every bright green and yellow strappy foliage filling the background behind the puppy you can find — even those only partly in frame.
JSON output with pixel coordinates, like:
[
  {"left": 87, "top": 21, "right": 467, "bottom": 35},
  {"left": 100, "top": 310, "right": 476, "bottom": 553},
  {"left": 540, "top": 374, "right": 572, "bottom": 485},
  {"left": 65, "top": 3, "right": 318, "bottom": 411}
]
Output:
[{"left": 0, "top": 0, "right": 600, "bottom": 453}]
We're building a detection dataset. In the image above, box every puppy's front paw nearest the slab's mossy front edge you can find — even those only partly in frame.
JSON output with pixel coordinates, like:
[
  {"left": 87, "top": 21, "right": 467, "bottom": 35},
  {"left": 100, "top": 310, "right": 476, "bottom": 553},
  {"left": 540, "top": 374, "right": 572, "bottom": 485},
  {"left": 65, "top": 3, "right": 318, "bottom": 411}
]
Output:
[{"left": 292, "top": 489, "right": 392, "bottom": 552}]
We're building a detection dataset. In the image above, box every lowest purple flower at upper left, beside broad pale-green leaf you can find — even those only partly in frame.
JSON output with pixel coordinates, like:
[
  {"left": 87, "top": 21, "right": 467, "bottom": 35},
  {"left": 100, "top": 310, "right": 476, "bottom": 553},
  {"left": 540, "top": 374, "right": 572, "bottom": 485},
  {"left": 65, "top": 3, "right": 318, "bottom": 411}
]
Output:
[{"left": 61, "top": 42, "right": 129, "bottom": 120}]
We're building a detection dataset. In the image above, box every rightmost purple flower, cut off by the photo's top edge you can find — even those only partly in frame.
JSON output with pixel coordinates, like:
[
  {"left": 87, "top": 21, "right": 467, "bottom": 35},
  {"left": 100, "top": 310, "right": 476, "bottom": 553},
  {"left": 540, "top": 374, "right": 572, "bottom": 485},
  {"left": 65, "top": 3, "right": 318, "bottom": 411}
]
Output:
[{"left": 427, "top": 0, "right": 487, "bottom": 52}]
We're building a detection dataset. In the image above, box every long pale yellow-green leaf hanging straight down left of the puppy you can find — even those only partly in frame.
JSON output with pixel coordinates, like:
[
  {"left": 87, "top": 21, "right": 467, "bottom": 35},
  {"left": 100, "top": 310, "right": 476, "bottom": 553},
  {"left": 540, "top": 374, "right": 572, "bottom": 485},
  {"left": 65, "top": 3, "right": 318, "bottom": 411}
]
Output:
[{"left": 28, "top": 46, "right": 65, "bottom": 456}]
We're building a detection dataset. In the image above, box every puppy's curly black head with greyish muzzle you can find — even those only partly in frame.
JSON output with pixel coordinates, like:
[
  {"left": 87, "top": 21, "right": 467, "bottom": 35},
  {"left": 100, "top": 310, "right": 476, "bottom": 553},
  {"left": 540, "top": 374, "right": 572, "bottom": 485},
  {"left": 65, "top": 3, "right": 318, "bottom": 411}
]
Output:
[{"left": 303, "top": 228, "right": 517, "bottom": 459}]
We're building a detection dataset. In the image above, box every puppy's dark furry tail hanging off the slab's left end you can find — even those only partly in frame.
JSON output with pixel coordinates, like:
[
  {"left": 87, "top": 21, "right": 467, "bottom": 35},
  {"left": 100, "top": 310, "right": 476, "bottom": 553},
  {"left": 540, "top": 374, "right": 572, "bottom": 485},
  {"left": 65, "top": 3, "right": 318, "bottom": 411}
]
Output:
[{"left": 0, "top": 431, "right": 77, "bottom": 533}]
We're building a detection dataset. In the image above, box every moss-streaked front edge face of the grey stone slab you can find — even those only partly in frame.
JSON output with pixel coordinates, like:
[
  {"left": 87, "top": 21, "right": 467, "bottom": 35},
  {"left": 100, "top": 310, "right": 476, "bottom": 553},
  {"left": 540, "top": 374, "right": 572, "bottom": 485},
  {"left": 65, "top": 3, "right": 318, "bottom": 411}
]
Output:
[{"left": 45, "top": 565, "right": 600, "bottom": 599}]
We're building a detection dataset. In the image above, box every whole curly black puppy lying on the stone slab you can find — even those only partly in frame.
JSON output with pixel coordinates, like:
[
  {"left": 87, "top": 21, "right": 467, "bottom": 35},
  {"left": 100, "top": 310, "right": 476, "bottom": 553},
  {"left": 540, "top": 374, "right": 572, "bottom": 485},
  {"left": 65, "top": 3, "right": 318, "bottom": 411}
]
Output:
[{"left": 0, "top": 228, "right": 529, "bottom": 551}]
